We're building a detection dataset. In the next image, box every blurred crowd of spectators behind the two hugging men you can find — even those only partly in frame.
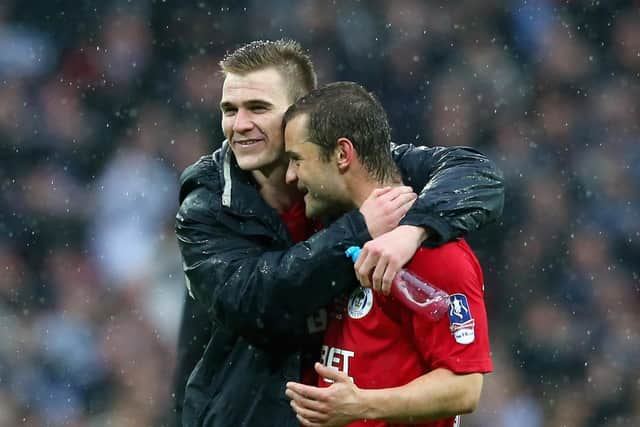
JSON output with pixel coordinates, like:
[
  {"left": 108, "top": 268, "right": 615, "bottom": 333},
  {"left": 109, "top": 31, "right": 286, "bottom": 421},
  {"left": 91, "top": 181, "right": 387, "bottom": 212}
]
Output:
[{"left": 0, "top": 0, "right": 640, "bottom": 427}]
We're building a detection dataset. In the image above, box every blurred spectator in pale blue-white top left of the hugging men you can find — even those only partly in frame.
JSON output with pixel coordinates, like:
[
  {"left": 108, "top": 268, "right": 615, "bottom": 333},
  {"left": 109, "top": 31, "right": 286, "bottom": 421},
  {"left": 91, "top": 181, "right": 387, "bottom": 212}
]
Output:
[{"left": 92, "top": 104, "right": 178, "bottom": 286}]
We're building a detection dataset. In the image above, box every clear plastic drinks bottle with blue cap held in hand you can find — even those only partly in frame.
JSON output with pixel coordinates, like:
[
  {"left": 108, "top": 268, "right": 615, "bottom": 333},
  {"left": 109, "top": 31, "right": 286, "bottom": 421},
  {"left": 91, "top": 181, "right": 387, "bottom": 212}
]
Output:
[{"left": 345, "top": 246, "right": 449, "bottom": 322}]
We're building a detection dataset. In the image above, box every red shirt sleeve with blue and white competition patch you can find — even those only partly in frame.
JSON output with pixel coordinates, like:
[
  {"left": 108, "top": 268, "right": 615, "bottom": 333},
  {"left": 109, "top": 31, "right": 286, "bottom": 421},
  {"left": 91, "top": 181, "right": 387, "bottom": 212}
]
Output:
[{"left": 407, "top": 240, "right": 493, "bottom": 374}]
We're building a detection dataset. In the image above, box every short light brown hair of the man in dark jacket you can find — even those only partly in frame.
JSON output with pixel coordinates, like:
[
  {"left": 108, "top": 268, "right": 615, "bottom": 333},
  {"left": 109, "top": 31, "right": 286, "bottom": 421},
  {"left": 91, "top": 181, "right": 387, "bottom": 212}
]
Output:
[{"left": 220, "top": 39, "right": 318, "bottom": 102}]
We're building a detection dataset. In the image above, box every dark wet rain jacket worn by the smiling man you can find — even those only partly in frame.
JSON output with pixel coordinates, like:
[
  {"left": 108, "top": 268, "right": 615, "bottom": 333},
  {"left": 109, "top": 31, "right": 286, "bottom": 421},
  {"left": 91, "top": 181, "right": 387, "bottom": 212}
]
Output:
[{"left": 176, "top": 144, "right": 504, "bottom": 427}]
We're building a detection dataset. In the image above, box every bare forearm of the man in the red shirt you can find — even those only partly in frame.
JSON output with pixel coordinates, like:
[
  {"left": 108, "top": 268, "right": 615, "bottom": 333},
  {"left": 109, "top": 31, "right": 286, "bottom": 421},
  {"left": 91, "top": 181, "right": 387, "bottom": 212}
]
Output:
[{"left": 360, "top": 369, "right": 482, "bottom": 423}]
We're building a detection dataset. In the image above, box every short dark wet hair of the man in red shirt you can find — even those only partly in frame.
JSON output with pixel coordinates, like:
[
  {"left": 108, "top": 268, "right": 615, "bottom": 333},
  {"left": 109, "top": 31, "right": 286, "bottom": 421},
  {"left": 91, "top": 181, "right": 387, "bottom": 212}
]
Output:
[{"left": 282, "top": 82, "right": 400, "bottom": 183}]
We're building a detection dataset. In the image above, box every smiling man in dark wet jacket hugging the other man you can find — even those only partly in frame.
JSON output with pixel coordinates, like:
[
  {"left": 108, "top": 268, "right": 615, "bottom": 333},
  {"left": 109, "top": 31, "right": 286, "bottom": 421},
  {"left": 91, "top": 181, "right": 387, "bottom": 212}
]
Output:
[{"left": 176, "top": 40, "right": 503, "bottom": 426}]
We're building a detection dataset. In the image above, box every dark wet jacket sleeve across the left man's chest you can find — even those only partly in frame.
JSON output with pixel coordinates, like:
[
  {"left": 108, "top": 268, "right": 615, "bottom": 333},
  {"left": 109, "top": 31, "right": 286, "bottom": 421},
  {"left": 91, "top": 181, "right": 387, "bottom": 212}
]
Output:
[{"left": 176, "top": 187, "right": 370, "bottom": 344}]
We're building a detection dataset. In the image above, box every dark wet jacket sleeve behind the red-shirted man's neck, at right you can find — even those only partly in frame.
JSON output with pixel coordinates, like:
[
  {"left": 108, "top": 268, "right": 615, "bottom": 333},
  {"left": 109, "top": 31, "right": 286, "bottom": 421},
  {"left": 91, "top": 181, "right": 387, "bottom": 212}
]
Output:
[{"left": 393, "top": 144, "right": 504, "bottom": 246}]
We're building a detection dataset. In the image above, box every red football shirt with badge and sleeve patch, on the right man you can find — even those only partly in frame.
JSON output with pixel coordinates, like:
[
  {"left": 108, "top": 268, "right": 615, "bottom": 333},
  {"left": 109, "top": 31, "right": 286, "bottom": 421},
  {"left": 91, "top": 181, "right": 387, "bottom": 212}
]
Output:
[{"left": 318, "top": 240, "right": 492, "bottom": 427}]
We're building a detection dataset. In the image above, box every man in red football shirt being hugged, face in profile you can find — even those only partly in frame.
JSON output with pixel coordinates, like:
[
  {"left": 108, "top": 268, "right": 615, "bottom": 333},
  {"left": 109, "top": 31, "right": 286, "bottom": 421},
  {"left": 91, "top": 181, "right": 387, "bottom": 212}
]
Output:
[{"left": 284, "top": 82, "right": 492, "bottom": 427}]
